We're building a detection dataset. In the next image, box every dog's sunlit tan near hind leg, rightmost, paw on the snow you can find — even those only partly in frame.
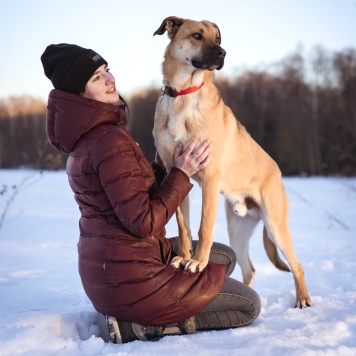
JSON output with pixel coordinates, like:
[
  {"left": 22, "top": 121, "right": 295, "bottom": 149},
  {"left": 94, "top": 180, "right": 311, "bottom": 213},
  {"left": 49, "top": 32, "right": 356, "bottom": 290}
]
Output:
[{"left": 261, "top": 184, "right": 311, "bottom": 308}]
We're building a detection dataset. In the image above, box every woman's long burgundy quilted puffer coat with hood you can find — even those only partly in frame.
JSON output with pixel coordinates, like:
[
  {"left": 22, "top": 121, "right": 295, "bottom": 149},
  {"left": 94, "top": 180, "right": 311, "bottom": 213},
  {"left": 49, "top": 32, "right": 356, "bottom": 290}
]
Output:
[{"left": 47, "top": 89, "right": 225, "bottom": 325}]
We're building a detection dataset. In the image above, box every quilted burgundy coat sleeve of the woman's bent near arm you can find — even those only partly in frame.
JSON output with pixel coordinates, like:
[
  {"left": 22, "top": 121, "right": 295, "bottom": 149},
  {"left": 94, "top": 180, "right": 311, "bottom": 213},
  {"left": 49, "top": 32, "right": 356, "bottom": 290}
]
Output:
[{"left": 93, "top": 130, "right": 192, "bottom": 237}]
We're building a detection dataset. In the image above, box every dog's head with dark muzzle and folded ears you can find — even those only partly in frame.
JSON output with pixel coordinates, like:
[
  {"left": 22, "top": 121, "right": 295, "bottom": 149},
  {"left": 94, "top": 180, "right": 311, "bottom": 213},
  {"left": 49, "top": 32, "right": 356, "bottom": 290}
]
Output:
[{"left": 153, "top": 16, "right": 226, "bottom": 71}]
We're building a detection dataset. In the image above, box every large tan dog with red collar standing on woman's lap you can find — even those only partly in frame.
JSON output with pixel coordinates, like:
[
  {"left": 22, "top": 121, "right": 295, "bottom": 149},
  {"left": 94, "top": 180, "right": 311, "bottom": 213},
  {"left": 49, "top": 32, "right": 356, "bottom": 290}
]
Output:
[{"left": 153, "top": 16, "right": 311, "bottom": 308}]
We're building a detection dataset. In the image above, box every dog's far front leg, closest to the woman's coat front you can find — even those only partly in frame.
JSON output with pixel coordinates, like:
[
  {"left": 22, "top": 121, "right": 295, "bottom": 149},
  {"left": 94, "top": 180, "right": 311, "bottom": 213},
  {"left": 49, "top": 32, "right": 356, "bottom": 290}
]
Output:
[{"left": 171, "top": 195, "right": 192, "bottom": 268}]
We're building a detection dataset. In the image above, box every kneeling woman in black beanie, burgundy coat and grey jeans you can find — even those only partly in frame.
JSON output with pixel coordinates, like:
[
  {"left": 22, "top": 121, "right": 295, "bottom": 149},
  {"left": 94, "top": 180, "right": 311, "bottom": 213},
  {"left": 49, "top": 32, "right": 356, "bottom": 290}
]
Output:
[{"left": 41, "top": 44, "right": 260, "bottom": 342}]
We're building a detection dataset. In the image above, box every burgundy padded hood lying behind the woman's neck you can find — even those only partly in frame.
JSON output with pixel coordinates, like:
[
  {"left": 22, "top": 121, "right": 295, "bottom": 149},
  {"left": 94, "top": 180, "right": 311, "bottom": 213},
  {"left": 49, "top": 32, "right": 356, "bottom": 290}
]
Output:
[{"left": 46, "top": 89, "right": 126, "bottom": 153}]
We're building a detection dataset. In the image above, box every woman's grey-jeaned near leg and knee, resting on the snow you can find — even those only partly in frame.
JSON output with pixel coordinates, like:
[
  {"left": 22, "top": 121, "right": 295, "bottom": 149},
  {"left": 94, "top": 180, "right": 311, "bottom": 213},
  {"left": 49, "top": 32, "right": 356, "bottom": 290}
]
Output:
[{"left": 195, "top": 277, "right": 261, "bottom": 330}]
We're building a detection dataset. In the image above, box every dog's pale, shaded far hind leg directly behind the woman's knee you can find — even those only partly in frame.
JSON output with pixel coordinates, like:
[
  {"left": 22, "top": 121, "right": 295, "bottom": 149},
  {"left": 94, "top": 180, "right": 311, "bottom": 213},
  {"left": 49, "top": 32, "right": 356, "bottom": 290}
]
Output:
[{"left": 225, "top": 199, "right": 259, "bottom": 287}]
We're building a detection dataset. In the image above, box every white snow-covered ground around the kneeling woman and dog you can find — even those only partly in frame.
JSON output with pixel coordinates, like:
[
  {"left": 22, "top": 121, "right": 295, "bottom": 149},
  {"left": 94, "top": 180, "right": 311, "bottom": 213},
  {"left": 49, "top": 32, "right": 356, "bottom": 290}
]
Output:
[{"left": 0, "top": 170, "right": 356, "bottom": 356}]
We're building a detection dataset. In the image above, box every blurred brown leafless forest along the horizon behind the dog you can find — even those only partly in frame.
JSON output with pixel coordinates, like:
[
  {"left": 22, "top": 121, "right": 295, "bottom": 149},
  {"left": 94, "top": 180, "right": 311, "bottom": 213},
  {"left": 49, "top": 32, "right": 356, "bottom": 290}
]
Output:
[{"left": 0, "top": 47, "right": 356, "bottom": 176}]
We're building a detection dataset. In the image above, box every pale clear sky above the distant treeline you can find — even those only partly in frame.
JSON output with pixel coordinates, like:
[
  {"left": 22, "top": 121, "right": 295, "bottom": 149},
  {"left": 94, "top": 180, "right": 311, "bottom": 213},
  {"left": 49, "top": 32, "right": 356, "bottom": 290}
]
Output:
[{"left": 0, "top": 0, "right": 356, "bottom": 100}]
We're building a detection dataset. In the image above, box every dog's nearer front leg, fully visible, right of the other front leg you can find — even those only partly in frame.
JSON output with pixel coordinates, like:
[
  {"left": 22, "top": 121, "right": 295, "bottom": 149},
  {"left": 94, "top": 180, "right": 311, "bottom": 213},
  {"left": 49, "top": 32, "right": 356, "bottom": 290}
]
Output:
[{"left": 185, "top": 175, "right": 220, "bottom": 272}]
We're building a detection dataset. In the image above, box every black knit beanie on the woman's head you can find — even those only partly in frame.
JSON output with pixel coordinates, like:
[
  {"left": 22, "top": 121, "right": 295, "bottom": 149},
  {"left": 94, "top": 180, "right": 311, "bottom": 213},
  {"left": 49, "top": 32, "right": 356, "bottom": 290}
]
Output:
[{"left": 41, "top": 43, "right": 108, "bottom": 95}]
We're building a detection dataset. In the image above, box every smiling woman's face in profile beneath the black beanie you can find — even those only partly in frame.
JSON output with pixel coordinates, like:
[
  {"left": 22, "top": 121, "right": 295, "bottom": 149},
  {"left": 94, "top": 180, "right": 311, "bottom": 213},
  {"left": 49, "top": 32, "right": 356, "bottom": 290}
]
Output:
[{"left": 82, "top": 64, "right": 119, "bottom": 104}]
